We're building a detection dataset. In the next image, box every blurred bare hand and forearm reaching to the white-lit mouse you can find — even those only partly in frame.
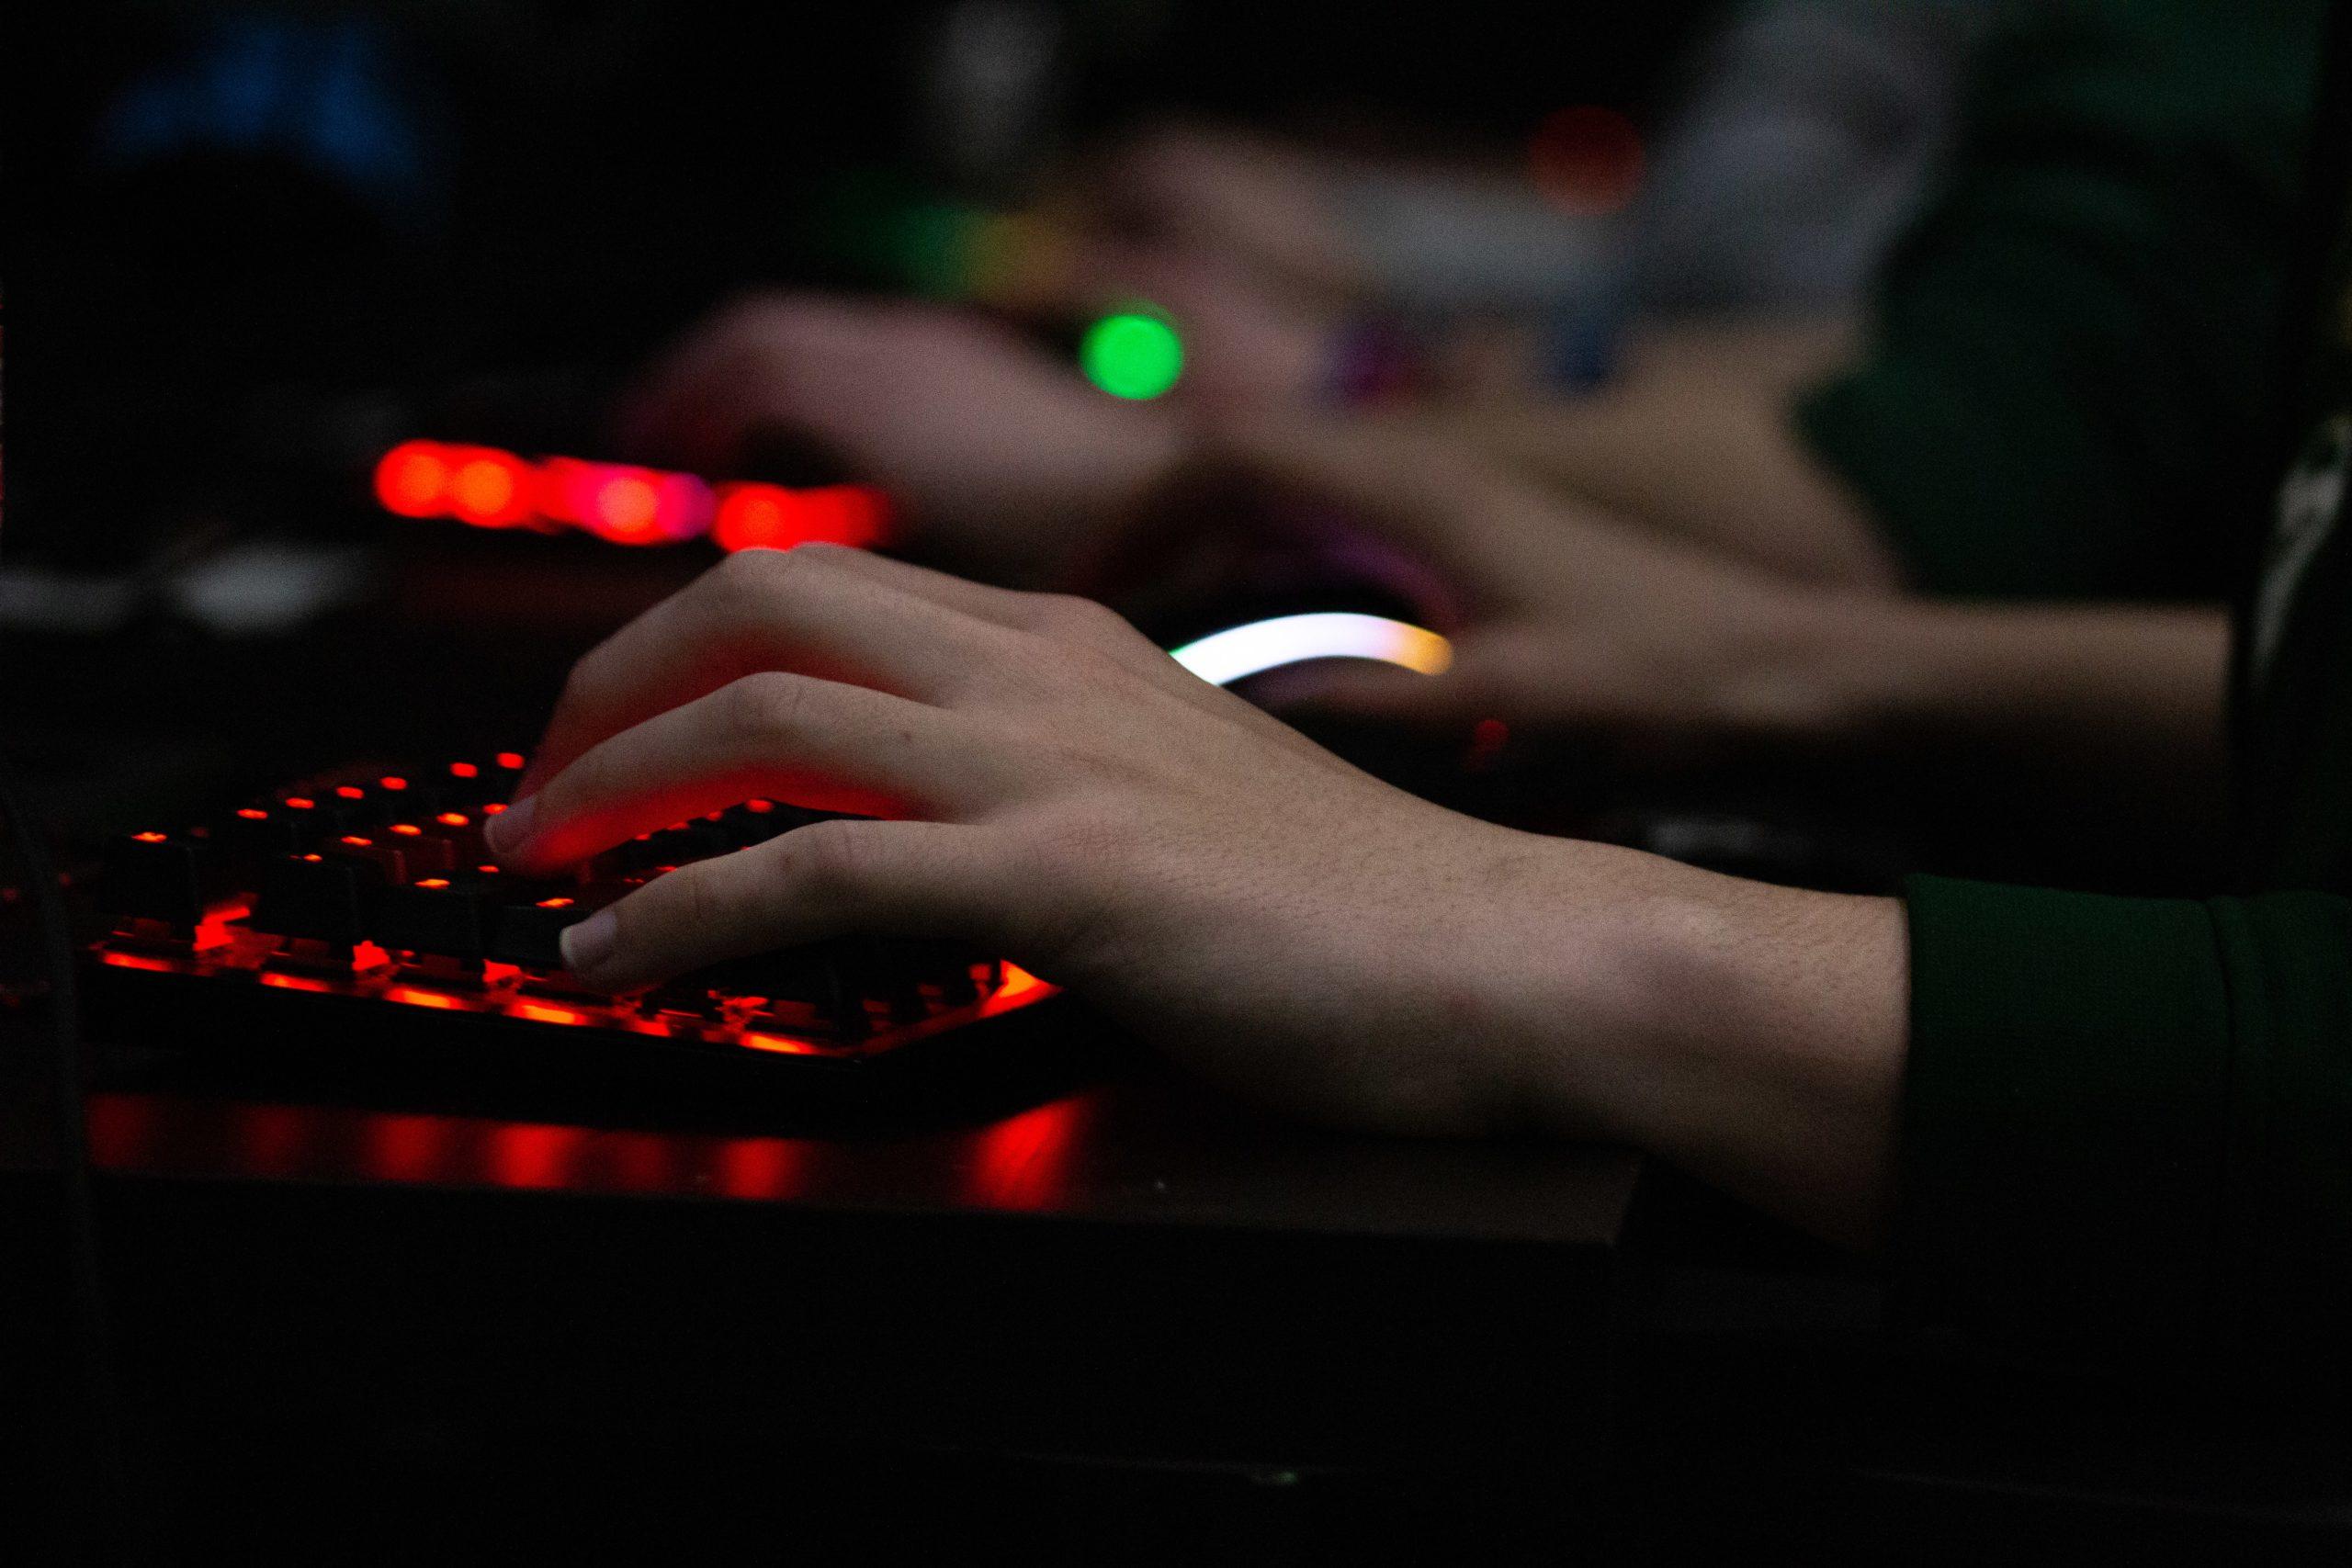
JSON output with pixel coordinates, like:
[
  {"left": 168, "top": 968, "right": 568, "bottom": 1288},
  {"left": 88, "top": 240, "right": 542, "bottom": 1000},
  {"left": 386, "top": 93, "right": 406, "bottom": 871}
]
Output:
[{"left": 1179, "top": 416, "right": 2227, "bottom": 865}]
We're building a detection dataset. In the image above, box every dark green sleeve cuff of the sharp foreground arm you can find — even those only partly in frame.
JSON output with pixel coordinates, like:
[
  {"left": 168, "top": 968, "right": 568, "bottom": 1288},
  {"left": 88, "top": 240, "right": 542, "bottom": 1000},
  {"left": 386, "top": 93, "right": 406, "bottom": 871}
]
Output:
[{"left": 1891, "top": 877, "right": 2352, "bottom": 1396}]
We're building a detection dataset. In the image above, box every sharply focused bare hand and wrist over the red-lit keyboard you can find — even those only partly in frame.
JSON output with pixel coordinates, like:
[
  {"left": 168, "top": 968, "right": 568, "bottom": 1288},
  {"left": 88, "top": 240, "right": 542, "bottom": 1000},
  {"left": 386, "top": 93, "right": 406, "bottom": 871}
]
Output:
[{"left": 492, "top": 546, "right": 1905, "bottom": 1239}]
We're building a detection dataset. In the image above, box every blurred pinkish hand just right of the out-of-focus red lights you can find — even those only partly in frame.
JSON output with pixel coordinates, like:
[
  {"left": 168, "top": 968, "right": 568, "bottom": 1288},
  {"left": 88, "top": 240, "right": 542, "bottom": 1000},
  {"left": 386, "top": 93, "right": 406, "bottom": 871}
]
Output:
[{"left": 623, "top": 296, "right": 1176, "bottom": 581}]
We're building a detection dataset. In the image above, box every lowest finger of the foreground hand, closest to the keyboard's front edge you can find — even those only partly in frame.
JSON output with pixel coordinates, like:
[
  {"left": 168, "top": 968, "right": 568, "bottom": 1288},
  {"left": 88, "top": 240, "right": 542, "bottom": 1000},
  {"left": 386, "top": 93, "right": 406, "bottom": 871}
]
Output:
[{"left": 562, "top": 820, "right": 1007, "bottom": 992}]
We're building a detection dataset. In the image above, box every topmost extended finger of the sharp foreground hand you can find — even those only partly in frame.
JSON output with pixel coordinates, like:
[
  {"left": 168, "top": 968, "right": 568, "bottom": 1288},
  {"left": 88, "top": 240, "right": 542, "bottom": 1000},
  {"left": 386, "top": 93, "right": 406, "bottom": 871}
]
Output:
[{"left": 515, "top": 546, "right": 1000, "bottom": 799}]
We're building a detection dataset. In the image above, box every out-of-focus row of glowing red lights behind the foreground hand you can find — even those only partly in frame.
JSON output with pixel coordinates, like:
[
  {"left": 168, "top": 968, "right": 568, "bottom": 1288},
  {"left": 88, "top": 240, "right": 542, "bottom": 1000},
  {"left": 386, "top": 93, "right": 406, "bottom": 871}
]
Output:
[{"left": 377, "top": 442, "right": 891, "bottom": 550}]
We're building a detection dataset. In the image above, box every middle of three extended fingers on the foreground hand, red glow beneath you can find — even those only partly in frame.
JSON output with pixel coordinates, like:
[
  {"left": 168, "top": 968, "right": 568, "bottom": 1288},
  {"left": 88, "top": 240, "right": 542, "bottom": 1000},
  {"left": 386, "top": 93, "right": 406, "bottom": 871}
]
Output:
[{"left": 489, "top": 672, "right": 1012, "bottom": 872}]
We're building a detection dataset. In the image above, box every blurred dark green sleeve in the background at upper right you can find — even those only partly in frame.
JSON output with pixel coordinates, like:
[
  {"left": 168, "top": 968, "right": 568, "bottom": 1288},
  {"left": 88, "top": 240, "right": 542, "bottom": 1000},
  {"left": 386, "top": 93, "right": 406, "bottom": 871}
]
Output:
[{"left": 1794, "top": 0, "right": 2326, "bottom": 597}]
